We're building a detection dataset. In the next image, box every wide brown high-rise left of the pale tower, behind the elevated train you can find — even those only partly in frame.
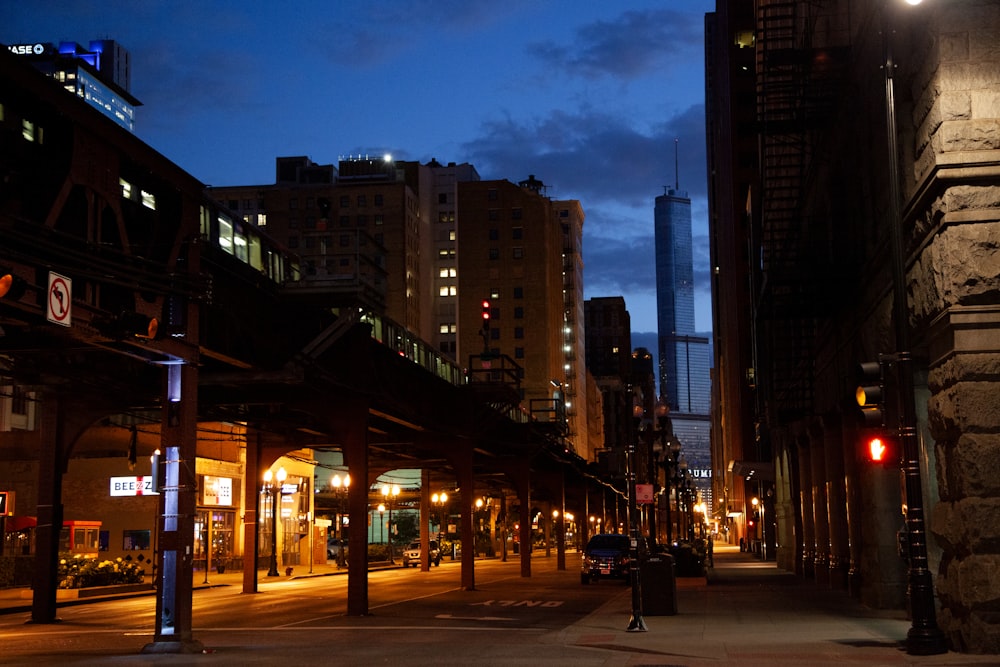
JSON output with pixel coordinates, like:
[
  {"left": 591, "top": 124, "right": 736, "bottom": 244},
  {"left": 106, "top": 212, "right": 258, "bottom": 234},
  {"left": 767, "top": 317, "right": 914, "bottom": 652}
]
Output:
[{"left": 209, "top": 156, "right": 431, "bottom": 340}]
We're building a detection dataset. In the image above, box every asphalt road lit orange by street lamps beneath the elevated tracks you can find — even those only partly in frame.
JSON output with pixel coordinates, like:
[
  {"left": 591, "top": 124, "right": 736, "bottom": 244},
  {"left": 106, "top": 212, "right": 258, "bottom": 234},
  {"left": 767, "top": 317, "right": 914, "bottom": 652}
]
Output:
[{"left": 0, "top": 557, "right": 626, "bottom": 666}]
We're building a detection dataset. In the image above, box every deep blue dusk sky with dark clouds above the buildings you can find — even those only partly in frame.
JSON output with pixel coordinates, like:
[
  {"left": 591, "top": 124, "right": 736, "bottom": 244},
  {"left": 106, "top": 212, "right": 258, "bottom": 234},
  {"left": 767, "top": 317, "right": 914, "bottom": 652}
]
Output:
[{"left": 0, "top": 0, "right": 714, "bottom": 332}]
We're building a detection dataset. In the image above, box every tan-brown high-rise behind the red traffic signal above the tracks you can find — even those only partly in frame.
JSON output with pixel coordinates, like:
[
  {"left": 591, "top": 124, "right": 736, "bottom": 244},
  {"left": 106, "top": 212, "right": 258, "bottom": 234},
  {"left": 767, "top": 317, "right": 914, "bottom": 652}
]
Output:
[{"left": 457, "top": 177, "right": 593, "bottom": 459}]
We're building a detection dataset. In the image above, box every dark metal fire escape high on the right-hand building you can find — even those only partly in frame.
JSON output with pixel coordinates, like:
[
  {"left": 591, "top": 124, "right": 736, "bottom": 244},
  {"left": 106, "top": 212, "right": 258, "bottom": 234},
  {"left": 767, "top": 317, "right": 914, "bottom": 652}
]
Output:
[{"left": 752, "top": 0, "right": 847, "bottom": 425}]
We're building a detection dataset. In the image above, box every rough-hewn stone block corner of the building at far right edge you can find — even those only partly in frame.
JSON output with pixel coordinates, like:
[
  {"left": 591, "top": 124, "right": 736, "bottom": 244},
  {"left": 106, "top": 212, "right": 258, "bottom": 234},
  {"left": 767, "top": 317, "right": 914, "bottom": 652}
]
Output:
[{"left": 907, "top": 0, "right": 1000, "bottom": 653}]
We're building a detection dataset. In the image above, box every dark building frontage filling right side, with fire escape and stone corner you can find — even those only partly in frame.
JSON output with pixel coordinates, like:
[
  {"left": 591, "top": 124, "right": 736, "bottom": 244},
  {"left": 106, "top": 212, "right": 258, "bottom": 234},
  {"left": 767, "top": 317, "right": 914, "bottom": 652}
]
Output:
[{"left": 708, "top": 0, "right": 1000, "bottom": 653}]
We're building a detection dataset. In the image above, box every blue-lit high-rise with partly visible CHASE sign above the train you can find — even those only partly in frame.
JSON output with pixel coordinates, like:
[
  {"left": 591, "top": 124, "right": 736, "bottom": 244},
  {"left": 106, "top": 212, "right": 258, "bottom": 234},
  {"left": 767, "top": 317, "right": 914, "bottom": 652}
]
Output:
[{"left": 7, "top": 39, "right": 141, "bottom": 132}]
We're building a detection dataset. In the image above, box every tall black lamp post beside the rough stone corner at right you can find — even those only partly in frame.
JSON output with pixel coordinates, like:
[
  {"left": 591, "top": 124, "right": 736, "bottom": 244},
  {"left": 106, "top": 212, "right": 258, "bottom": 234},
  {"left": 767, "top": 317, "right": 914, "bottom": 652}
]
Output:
[{"left": 882, "top": 0, "right": 948, "bottom": 655}]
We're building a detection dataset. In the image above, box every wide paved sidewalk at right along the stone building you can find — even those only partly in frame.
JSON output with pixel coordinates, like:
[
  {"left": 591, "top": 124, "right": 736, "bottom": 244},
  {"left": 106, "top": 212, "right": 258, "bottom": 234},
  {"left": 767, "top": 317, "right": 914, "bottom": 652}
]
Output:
[{"left": 562, "top": 545, "right": 1000, "bottom": 667}]
